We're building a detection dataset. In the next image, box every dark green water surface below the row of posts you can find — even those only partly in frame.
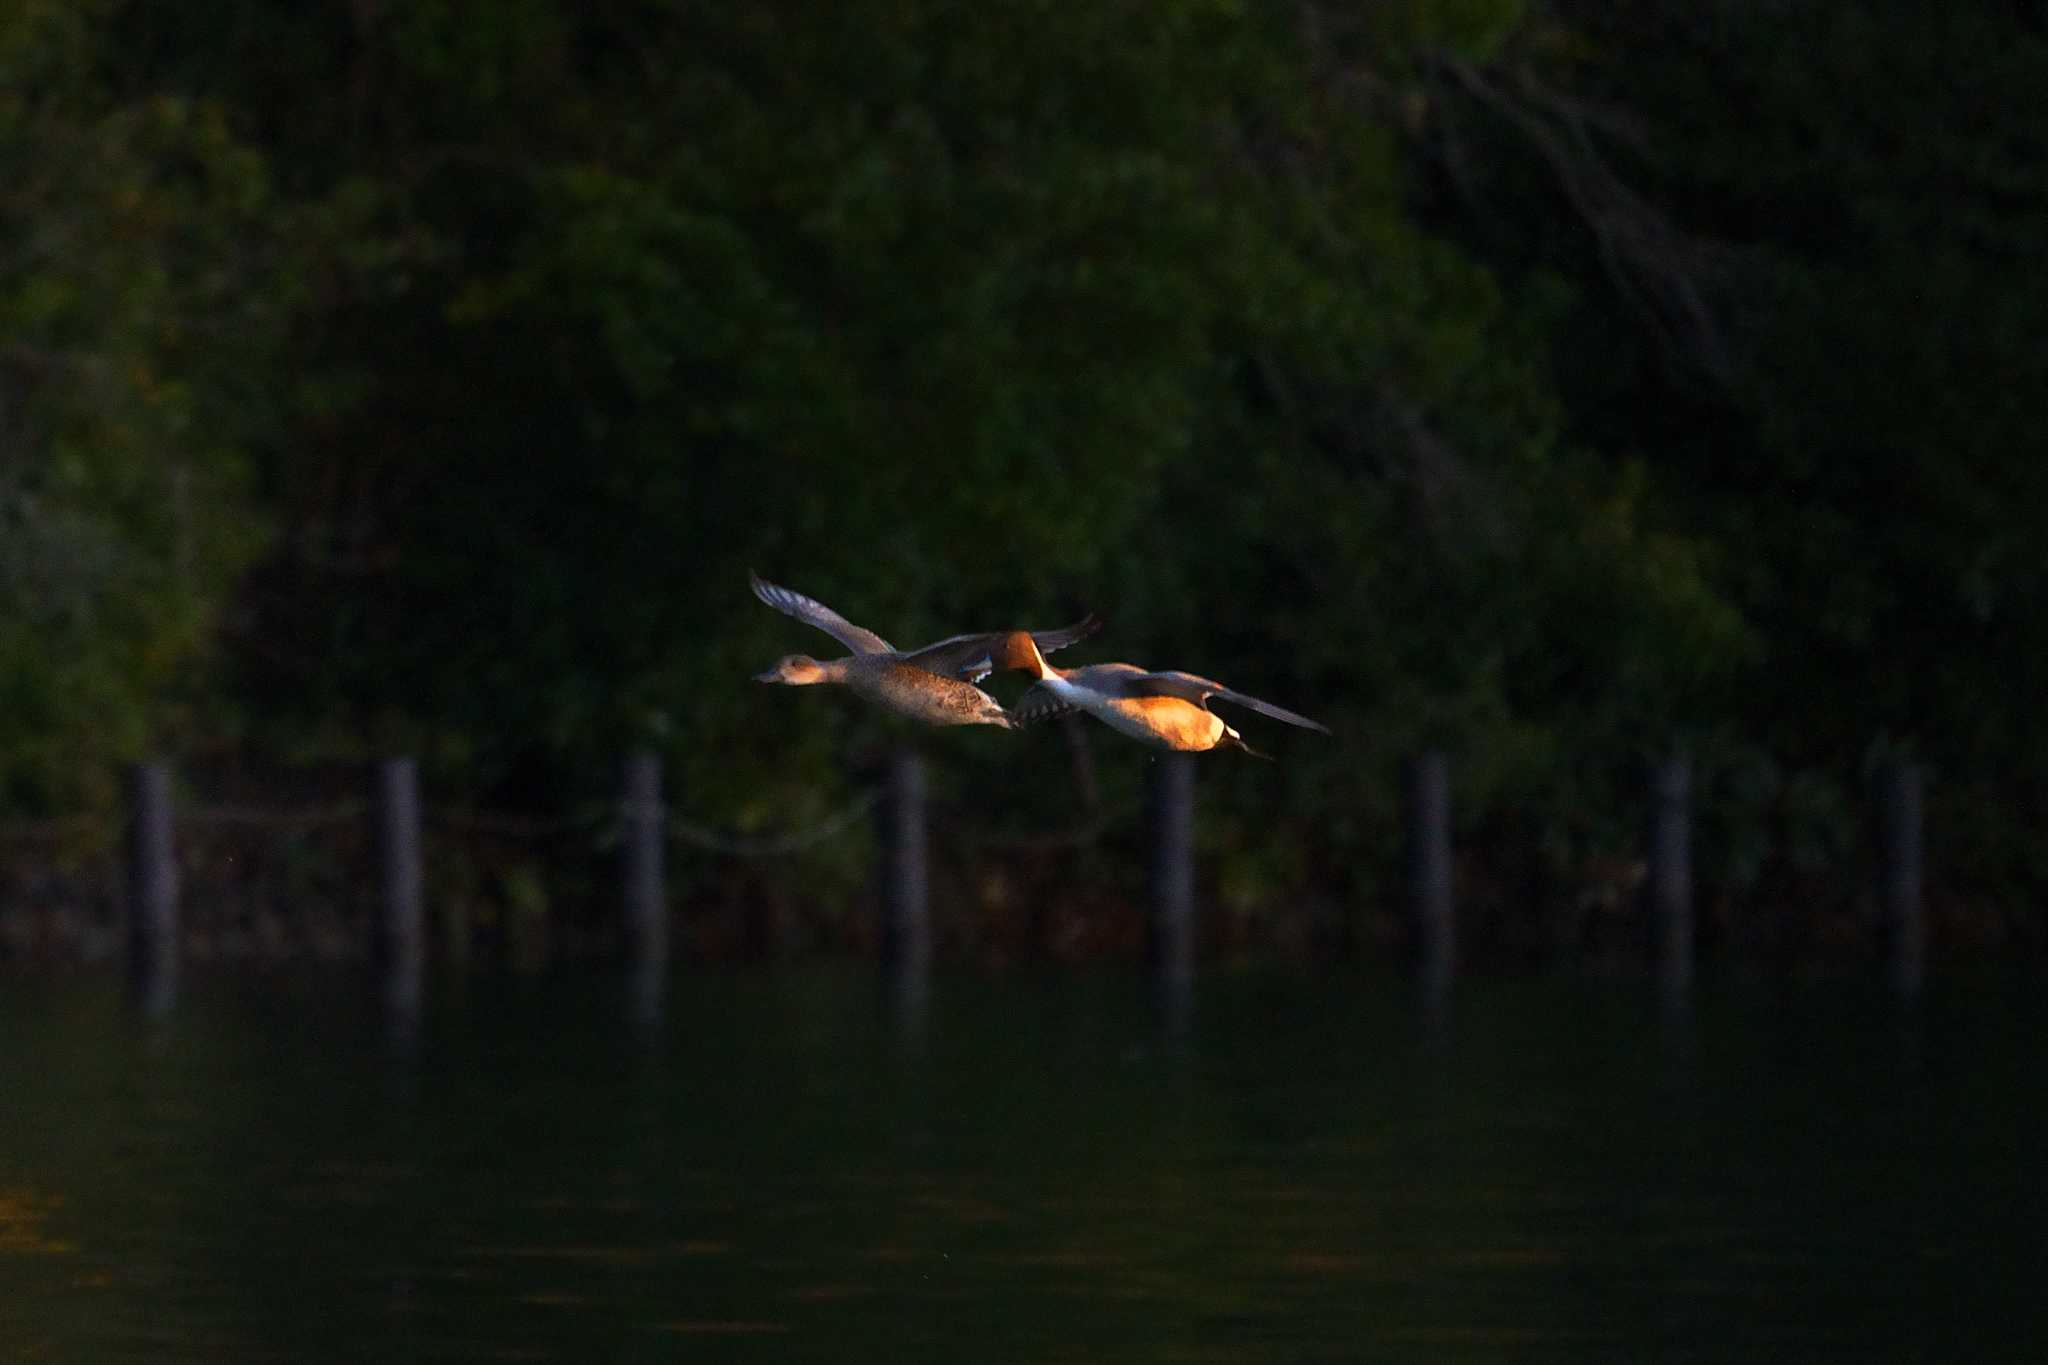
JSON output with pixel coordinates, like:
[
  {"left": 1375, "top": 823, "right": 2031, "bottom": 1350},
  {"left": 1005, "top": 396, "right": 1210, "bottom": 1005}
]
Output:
[{"left": 0, "top": 970, "right": 2048, "bottom": 1365}]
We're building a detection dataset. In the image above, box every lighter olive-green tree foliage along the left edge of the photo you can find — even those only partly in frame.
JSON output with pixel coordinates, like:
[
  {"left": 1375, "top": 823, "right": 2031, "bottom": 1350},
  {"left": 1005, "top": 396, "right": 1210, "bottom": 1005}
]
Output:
[{"left": 0, "top": 4, "right": 279, "bottom": 808}]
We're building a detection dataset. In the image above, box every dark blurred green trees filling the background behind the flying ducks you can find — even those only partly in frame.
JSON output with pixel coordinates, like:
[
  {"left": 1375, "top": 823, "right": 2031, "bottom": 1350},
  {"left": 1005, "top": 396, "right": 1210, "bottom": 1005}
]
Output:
[{"left": 0, "top": 0, "right": 2048, "bottom": 954}]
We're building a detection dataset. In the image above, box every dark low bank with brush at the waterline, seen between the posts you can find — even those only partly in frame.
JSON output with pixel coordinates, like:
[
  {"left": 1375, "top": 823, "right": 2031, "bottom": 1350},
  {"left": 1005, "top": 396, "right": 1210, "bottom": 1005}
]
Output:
[{"left": 0, "top": 749, "right": 2015, "bottom": 974}]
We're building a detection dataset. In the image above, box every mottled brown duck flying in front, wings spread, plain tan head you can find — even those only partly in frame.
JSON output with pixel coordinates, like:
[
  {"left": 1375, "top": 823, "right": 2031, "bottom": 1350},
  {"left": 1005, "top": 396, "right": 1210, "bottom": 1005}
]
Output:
[{"left": 748, "top": 573, "right": 1102, "bottom": 729}]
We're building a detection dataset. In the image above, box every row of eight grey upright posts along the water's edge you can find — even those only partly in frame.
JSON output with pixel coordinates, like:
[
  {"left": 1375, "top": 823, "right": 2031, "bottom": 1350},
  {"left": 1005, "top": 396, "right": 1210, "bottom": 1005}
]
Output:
[{"left": 127, "top": 751, "right": 1925, "bottom": 1015}]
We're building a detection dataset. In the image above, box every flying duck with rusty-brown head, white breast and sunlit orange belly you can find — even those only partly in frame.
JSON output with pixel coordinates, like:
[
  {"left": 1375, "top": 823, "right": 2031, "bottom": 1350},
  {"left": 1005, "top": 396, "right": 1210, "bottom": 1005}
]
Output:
[{"left": 989, "top": 630, "right": 1329, "bottom": 757}]
